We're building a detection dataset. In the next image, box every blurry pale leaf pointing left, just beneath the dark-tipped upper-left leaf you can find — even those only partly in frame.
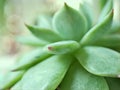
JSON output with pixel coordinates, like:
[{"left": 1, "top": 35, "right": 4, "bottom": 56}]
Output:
[{"left": 16, "top": 36, "right": 48, "bottom": 46}]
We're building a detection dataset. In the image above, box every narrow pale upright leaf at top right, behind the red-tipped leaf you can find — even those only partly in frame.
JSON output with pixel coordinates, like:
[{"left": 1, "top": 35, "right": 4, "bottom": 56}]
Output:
[{"left": 99, "top": 0, "right": 113, "bottom": 22}]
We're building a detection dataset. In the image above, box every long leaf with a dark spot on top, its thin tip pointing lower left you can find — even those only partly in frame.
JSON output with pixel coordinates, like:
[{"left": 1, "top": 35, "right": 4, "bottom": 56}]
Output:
[{"left": 13, "top": 48, "right": 51, "bottom": 71}]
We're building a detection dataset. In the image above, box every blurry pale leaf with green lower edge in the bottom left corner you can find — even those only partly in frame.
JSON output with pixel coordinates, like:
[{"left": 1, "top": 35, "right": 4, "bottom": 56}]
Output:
[{"left": 0, "top": 71, "right": 25, "bottom": 90}]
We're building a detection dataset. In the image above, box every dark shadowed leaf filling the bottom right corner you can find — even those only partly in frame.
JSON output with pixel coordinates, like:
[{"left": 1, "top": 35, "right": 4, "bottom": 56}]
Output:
[{"left": 106, "top": 78, "right": 120, "bottom": 90}]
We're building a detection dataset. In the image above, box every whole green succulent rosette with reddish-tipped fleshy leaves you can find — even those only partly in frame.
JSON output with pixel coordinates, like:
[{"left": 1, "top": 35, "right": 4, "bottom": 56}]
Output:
[{"left": 1, "top": 0, "right": 120, "bottom": 90}]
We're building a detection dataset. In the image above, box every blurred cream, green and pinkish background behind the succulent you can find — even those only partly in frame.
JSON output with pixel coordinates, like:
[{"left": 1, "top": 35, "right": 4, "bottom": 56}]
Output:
[{"left": 0, "top": 0, "right": 120, "bottom": 80}]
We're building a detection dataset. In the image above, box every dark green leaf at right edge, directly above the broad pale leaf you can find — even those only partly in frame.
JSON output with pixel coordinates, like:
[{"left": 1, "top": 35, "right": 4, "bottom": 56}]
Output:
[{"left": 95, "top": 34, "right": 120, "bottom": 48}]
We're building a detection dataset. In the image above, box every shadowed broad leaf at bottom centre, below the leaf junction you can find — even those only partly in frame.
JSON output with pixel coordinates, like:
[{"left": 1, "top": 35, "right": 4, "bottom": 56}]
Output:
[{"left": 60, "top": 62, "right": 109, "bottom": 90}]
